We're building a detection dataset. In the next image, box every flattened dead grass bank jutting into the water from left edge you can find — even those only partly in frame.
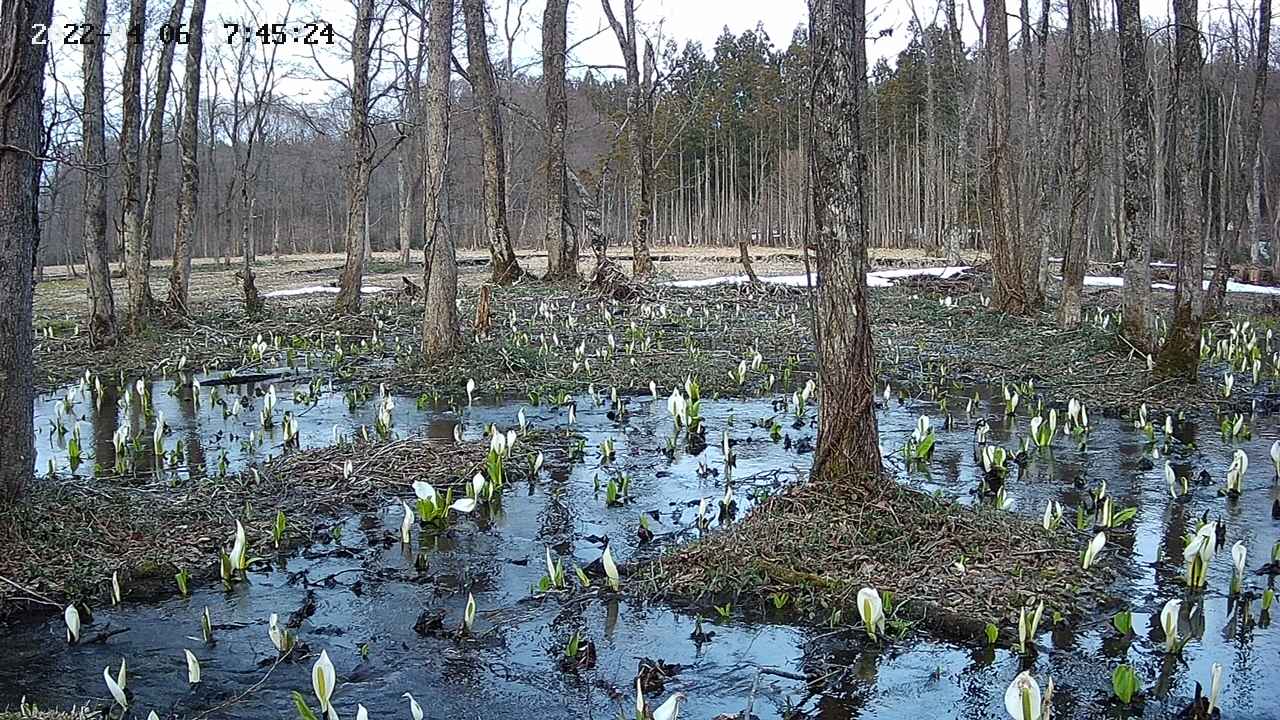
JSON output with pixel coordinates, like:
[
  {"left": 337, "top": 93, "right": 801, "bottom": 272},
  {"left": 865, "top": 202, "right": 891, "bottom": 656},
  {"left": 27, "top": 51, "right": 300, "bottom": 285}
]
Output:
[{"left": 0, "top": 427, "right": 562, "bottom": 616}]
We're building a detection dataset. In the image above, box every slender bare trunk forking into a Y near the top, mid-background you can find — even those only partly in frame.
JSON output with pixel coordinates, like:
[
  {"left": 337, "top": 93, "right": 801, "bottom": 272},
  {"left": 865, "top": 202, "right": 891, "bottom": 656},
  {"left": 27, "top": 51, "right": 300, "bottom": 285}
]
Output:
[{"left": 600, "top": 0, "right": 655, "bottom": 278}]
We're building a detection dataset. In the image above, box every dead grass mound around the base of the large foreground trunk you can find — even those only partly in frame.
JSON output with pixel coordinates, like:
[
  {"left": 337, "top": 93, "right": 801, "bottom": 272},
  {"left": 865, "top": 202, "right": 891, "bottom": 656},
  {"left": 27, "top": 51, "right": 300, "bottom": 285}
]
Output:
[{"left": 632, "top": 480, "right": 1107, "bottom": 642}]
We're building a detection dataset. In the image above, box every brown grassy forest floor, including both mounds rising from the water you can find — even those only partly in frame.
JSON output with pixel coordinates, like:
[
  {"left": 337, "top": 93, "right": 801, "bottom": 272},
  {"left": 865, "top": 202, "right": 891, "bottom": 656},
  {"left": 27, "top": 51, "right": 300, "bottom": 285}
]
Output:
[{"left": 12, "top": 243, "right": 1277, "bottom": 637}]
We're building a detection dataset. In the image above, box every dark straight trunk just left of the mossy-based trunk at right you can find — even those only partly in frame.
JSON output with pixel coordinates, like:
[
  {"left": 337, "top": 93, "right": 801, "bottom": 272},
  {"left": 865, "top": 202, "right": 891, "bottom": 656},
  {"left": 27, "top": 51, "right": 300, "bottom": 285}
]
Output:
[{"left": 1116, "top": 0, "right": 1155, "bottom": 352}]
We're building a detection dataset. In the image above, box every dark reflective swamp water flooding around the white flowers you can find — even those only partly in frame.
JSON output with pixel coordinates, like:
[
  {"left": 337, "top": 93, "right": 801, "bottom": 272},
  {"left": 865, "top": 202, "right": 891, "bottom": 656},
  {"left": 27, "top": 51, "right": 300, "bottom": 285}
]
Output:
[{"left": 0, "top": 378, "right": 1280, "bottom": 720}]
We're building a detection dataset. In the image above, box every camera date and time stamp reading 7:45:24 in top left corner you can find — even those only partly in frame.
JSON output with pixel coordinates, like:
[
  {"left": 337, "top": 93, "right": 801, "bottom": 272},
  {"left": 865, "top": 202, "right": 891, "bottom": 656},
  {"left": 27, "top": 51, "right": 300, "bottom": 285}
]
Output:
[{"left": 31, "top": 22, "right": 334, "bottom": 45}]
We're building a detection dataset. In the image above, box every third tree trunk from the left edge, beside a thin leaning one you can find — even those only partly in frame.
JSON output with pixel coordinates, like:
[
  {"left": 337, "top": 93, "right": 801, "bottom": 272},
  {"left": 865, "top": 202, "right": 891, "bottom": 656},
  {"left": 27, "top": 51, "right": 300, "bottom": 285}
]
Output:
[{"left": 120, "top": 0, "right": 152, "bottom": 333}]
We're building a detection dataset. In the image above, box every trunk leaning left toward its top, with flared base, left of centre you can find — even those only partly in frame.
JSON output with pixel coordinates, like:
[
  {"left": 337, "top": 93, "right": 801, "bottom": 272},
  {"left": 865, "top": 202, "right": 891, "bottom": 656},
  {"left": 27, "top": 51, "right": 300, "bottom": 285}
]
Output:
[{"left": 462, "top": 0, "right": 525, "bottom": 284}]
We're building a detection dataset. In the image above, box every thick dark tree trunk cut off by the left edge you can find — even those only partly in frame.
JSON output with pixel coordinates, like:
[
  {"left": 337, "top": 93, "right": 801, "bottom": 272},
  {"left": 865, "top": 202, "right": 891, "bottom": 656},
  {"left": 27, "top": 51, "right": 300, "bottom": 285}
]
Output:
[{"left": 0, "top": 0, "right": 54, "bottom": 507}]
